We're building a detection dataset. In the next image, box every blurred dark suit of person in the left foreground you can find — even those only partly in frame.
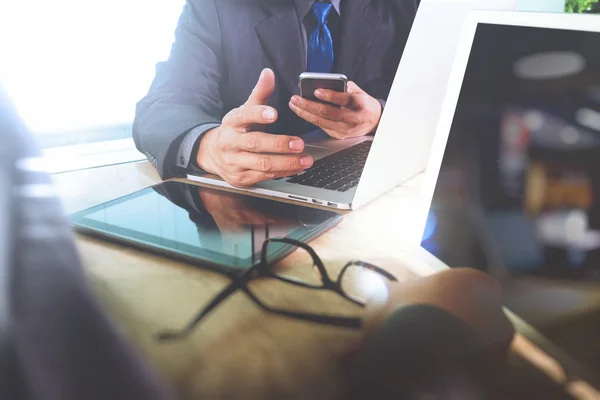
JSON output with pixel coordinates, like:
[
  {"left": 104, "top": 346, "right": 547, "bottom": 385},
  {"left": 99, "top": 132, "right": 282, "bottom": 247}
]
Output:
[{"left": 0, "top": 88, "right": 174, "bottom": 400}]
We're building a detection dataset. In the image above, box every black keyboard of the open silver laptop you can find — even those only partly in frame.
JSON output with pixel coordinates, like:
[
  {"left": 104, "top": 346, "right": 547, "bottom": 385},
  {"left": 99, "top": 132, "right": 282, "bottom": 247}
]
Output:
[{"left": 287, "top": 140, "right": 373, "bottom": 192}]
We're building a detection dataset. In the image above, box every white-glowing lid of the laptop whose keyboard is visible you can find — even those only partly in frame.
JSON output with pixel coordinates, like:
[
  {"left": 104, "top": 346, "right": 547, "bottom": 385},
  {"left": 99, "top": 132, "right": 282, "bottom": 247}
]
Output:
[{"left": 352, "top": 0, "right": 516, "bottom": 209}]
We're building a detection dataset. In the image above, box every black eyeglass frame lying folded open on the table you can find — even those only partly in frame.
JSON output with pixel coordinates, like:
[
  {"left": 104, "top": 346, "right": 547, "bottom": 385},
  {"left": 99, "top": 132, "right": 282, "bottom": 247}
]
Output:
[{"left": 155, "top": 238, "right": 398, "bottom": 342}]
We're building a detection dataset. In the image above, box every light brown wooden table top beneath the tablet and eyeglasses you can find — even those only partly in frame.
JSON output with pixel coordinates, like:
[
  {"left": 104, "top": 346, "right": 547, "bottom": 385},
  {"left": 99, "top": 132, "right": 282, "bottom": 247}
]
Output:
[{"left": 53, "top": 162, "right": 600, "bottom": 399}]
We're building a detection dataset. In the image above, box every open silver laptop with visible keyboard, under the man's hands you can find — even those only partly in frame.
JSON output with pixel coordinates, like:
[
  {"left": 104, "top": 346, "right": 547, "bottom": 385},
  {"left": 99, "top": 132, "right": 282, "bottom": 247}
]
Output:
[{"left": 188, "top": 0, "right": 514, "bottom": 209}]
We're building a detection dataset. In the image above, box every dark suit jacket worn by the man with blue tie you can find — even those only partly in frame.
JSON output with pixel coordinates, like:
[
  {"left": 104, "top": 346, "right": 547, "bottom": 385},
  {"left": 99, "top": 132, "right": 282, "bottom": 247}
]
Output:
[{"left": 133, "top": 0, "right": 419, "bottom": 178}]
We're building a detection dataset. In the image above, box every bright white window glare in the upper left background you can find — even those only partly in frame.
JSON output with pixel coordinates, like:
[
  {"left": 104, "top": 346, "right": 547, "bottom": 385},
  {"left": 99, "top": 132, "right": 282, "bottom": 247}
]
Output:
[{"left": 0, "top": 0, "right": 184, "bottom": 135}]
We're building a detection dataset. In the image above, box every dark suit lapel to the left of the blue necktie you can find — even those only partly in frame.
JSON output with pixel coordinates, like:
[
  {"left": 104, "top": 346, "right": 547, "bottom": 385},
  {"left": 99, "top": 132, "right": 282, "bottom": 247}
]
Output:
[{"left": 256, "top": 0, "right": 305, "bottom": 94}]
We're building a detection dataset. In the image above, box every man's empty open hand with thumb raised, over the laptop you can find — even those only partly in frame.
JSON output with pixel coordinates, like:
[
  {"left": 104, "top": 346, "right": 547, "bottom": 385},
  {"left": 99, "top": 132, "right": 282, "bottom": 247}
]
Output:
[{"left": 197, "top": 69, "right": 313, "bottom": 187}]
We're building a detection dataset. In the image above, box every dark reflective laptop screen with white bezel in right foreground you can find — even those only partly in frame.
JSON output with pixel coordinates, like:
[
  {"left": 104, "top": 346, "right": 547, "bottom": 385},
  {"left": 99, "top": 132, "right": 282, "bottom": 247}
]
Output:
[{"left": 422, "top": 18, "right": 600, "bottom": 384}]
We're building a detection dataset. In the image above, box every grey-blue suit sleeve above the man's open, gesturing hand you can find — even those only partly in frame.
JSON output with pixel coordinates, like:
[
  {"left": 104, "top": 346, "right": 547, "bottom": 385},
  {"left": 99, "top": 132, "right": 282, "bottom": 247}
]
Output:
[{"left": 133, "top": 0, "right": 223, "bottom": 179}]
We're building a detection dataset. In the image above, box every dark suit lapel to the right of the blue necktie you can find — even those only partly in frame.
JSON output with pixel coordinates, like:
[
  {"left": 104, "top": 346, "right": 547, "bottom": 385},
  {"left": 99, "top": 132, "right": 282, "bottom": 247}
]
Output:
[{"left": 336, "top": 0, "right": 381, "bottom": 79}]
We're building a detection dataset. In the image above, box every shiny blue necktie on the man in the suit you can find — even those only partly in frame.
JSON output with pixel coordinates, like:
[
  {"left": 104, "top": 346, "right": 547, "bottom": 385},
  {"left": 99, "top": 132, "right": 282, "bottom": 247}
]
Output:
[{"left": 308, "top": 1, "right": 333, "bottom": 72}]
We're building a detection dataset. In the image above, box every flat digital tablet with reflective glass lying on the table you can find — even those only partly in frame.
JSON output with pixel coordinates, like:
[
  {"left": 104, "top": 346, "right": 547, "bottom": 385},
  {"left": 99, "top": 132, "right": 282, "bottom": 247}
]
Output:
[{"left": 70, "top": 181, "right": 342, "bottom": 273}]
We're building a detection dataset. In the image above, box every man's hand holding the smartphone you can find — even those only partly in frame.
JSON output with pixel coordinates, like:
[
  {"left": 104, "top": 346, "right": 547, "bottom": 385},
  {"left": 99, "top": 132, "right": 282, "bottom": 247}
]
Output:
[{"left": 290, "top": 82, "right": 383, "bottom": 139}]
